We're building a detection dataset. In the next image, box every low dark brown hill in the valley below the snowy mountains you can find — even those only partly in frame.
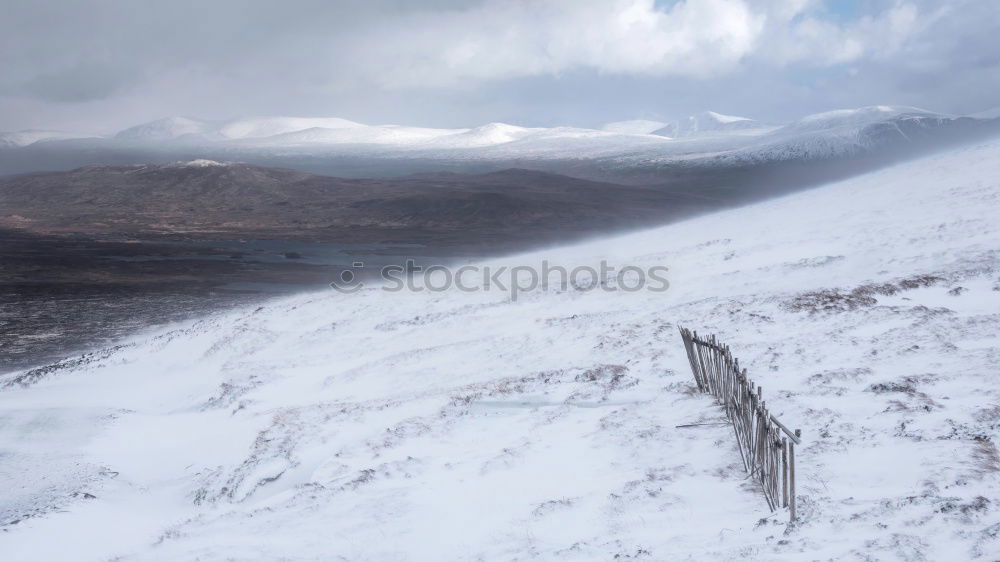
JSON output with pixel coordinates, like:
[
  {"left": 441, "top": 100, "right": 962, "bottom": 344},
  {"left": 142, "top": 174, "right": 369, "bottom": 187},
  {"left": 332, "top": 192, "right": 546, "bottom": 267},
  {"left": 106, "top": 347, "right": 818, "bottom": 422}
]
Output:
[{"left": 0, "top": 160, "right": 701, "bottom": 247}]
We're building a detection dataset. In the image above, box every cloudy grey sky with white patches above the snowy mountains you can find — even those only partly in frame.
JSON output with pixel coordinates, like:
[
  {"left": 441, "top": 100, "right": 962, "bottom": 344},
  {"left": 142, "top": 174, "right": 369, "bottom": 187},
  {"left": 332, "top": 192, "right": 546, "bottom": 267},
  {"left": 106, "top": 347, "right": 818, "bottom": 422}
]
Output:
[{"left": 0, "top": 0, "right": 1000, "bottom": 133}]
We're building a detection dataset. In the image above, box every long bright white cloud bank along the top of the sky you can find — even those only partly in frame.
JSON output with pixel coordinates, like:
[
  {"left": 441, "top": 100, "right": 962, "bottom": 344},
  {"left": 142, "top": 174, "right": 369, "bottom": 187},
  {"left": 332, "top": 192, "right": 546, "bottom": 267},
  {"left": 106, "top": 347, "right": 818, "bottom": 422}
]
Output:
[{"left": 334, "top": 0, "right": 921, "bottom": 88}]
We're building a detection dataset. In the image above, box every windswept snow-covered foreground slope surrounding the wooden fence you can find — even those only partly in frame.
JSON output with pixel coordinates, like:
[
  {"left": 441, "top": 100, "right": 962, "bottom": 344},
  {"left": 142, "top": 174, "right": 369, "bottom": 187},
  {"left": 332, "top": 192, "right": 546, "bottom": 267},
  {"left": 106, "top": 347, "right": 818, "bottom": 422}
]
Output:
[{"left": 0, "top": 142, "right": 1000, "bottom": 561}]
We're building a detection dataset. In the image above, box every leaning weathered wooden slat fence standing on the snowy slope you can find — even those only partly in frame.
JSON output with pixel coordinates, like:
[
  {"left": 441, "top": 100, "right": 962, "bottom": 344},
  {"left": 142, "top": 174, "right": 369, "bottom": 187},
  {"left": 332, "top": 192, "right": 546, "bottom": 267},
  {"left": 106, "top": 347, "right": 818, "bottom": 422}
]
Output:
[{"left": 680, "top": 328, "right": 802, "bottom": 521}]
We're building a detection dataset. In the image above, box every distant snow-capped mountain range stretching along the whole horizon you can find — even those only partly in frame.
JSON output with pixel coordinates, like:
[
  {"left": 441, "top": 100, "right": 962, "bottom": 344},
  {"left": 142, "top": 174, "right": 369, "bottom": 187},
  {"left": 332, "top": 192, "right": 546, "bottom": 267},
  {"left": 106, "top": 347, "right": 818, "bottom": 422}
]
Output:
[{"left": 0, "top": 106, "right": 1000, "bottom": 178}]
